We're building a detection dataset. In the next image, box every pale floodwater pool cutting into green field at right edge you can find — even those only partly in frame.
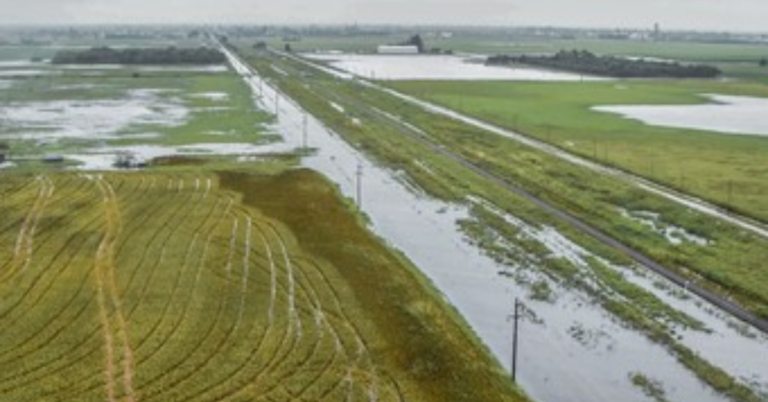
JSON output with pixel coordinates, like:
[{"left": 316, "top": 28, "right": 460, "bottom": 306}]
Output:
[{"left": 593, "top": 94, "right": 768, "bottom": 136}]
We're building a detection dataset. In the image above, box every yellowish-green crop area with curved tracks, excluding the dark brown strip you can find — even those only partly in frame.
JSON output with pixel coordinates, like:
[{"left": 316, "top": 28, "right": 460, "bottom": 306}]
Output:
[{"left": 0, "top": 174, "right": 412, "bottom": 402}]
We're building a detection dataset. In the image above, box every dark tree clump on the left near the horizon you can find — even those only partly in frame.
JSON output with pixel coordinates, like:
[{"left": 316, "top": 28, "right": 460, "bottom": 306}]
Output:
[{"left": 51, "top": 46, "right": 226, "bottom": 64}]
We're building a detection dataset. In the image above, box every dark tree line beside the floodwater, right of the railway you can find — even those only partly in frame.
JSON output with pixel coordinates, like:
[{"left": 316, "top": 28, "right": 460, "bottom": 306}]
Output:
[{"left": 486, "top": 50, "right": 722, "bottom": 78}]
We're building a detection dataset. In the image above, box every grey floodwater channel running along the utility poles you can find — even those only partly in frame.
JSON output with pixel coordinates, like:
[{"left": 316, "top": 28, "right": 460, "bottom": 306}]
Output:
[{"left": 222, "top": 48, "right": 768, "bottom": 402}]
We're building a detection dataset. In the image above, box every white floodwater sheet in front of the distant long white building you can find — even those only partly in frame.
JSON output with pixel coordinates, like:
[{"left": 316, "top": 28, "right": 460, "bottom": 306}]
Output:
[{"left": 307, "top": 54, "right": 597, "bottom": 81}]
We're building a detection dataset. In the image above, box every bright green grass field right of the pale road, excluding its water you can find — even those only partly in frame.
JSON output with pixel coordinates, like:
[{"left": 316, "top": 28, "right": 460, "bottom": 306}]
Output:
[{"left": 391, "top": 81, "right": 768, "bottom": 220}]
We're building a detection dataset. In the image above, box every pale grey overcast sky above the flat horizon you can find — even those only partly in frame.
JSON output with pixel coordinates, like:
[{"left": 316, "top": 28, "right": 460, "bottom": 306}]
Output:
[{"left": 0, "top": 0, "right": 768, "bottom": 32}]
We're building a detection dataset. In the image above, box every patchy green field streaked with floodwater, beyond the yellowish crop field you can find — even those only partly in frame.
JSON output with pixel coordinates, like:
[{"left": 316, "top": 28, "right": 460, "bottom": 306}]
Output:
[{"left": 0, "top": 61, "right": 275, "bottom": 170}]
